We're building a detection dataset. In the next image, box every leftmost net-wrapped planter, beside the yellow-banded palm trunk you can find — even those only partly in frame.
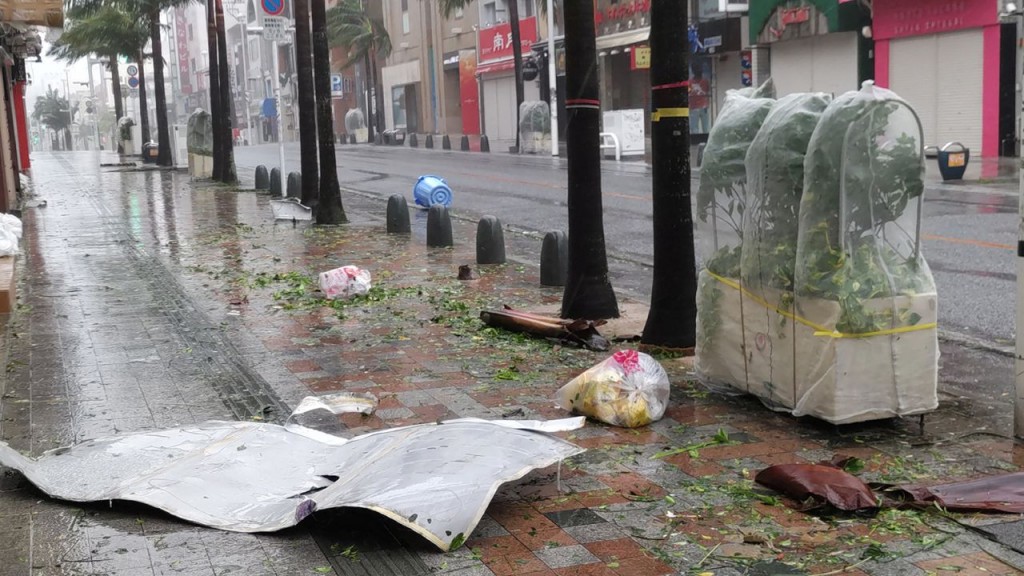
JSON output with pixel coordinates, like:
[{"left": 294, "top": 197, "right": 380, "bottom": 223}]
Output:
[{"left": 694, "top": 81, "right": 775, "bottom": 388}]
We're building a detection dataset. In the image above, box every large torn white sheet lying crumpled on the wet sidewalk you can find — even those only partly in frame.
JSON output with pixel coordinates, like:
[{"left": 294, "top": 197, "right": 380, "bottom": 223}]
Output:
[{"left": 0, "top": 403, "right": 584, "bottom": 550}]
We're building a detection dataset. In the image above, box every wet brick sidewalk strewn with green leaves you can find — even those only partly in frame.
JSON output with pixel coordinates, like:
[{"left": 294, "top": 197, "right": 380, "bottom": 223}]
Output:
[{"left": 0, "top": 153, "right": 1024, "bottom": 576}]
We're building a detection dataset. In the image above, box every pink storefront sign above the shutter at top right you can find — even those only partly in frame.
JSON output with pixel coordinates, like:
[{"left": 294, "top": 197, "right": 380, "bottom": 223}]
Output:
[{"left": 872, "top": 0, "right": 999, "bottom": 40}]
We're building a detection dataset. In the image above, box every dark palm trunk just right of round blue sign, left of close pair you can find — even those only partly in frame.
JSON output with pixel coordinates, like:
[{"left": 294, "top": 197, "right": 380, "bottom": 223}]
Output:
[{"left": 295, "top": 0, "right": 317, "bottom": 206}]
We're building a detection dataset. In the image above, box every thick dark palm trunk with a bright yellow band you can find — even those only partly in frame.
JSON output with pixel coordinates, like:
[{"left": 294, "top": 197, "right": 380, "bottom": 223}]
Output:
[{"left": 641, "top": 0, "right": 697, "bottom": 348}]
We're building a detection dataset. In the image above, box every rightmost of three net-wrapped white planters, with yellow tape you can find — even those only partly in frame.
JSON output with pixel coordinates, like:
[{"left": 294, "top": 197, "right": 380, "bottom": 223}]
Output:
[{"left": 792, "top": 82, "right": 938, "bottom": 423}]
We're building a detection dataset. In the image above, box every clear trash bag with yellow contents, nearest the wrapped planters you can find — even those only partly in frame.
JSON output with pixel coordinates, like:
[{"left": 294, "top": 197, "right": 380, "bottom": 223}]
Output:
[{"left": 557, "top": 349, "right": 669, "bottom": 428}]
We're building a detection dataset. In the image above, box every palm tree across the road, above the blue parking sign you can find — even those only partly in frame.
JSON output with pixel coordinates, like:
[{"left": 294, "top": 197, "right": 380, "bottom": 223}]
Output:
[{"left": 327, "top": 0, "right": 391, "bottom": 141}]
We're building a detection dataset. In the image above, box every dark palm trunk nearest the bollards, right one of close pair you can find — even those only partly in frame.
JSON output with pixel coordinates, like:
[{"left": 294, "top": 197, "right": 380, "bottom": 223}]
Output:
[{"left": 310, "top": 0, "right": 348, "bottom": 224}]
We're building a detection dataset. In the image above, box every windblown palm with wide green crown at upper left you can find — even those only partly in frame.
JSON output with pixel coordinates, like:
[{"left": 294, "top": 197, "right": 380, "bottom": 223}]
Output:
[{"left": 47, "top": 3, "right": 148, "bottom": 152}]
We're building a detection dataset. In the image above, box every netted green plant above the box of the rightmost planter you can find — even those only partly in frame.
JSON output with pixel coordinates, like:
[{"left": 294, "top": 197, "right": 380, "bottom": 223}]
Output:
[{"left": 796, "top": 84, "right": 934, "bottom": 334}]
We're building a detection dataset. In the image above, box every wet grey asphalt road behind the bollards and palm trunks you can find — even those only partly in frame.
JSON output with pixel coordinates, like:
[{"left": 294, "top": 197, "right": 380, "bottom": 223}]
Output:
[{"left": 236, "top": 143, "right": 1018, "bottom": 346}]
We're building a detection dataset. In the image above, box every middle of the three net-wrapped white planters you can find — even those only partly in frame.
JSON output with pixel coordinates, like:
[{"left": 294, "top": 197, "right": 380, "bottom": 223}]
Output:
[{"left": 739, "top": 93, "right": 831, "bottom": 410}]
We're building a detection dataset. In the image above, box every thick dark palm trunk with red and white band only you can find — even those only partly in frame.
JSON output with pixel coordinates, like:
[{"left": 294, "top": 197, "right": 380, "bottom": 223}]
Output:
[{"left": 562, "top": 2, "right": 618, "bottom": 320}]
